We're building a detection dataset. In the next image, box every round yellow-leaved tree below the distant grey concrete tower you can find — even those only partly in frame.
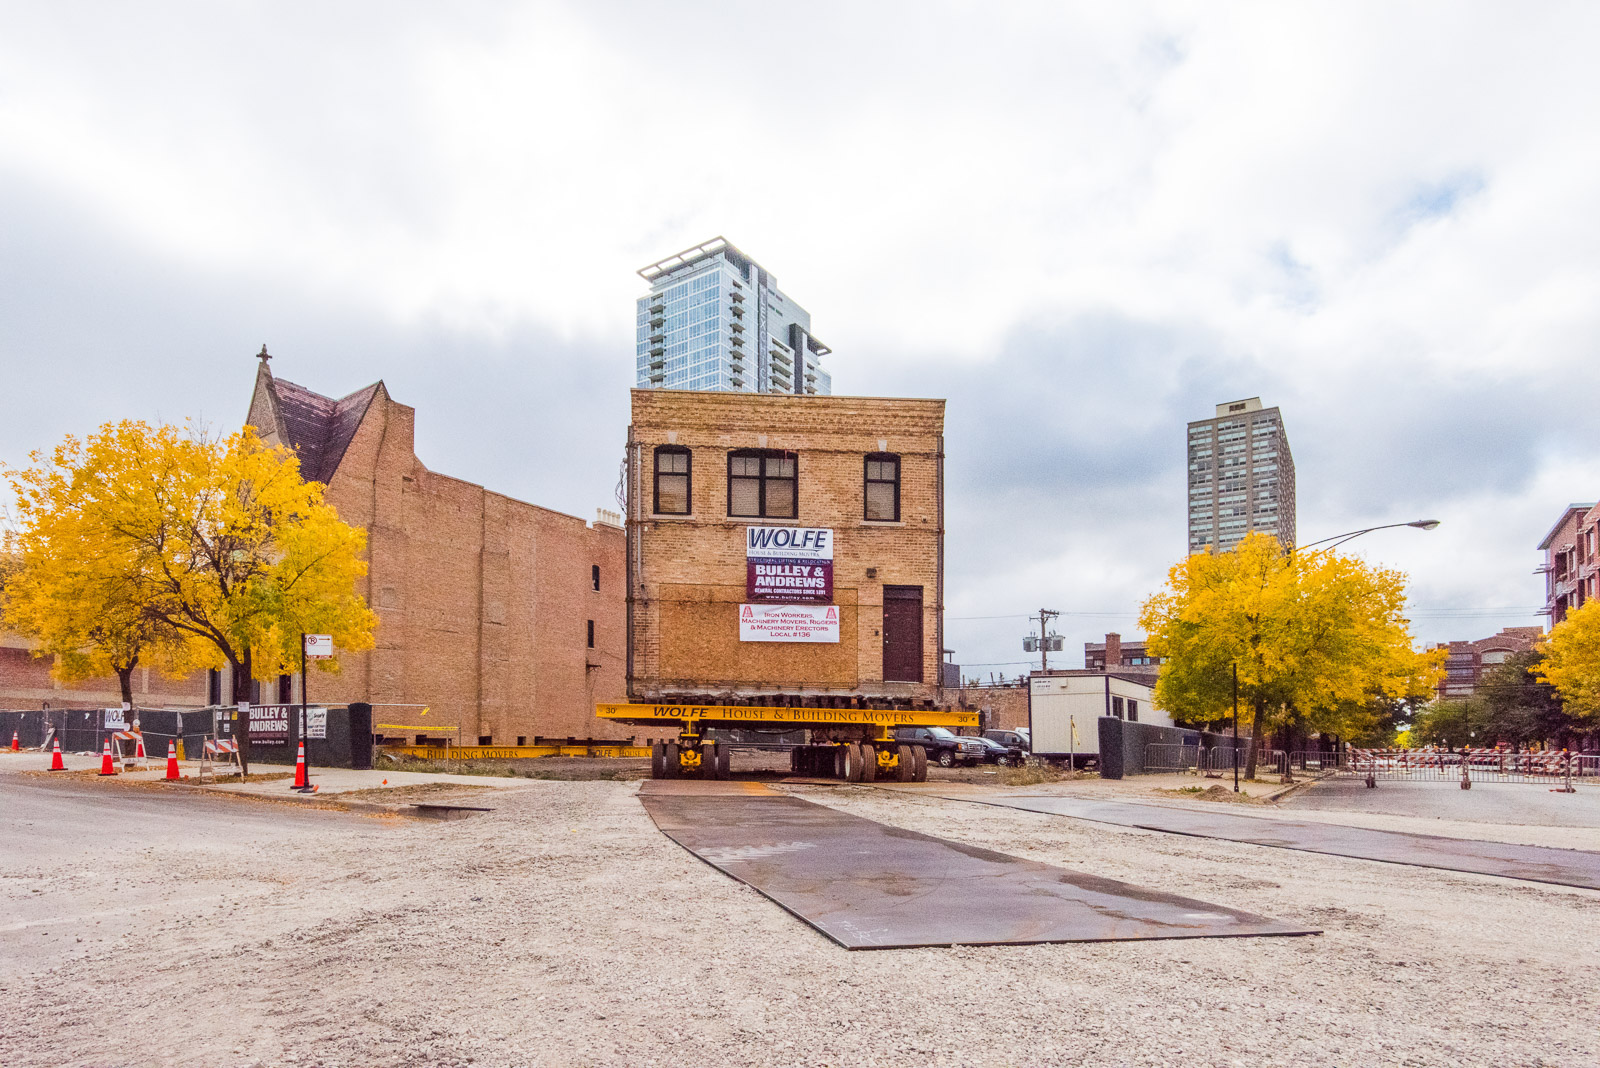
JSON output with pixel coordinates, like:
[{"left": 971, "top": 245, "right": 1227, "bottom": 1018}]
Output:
[{"left": 1139, "top": 532, "right": 1443, "bottom": 777}]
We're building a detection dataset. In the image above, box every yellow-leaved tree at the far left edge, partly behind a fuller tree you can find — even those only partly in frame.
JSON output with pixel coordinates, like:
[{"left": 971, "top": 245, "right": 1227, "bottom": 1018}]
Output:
[{"left": 0, "top": 425, "right": 197, "bottom": 705}]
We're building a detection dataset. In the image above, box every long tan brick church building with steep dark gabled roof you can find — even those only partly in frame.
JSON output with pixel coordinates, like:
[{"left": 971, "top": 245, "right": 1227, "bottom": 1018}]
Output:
[{"left": 246, "top": 356, "right": 626, "bottom": 745}]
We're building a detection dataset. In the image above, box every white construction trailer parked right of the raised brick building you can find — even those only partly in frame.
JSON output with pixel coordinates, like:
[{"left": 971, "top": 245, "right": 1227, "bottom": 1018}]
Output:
[{"left": 1027, "top": 670, "right": 1173, "bottom": 766}]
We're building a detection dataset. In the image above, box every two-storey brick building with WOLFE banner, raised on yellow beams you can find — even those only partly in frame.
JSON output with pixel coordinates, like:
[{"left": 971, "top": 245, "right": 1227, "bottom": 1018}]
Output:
[{"left": 627, "top": 390, "right": 944, "bottom": 705}]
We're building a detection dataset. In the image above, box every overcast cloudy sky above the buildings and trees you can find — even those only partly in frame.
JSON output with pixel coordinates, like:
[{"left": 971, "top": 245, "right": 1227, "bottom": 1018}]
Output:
[{"left": 0, "top": 0, "right": 1600, "bottom": 675}]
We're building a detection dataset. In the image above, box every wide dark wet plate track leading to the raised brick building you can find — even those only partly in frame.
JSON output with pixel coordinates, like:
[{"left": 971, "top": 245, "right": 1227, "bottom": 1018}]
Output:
[{"left": 638, "top": 780, "right": 1318, "bottom": 950}]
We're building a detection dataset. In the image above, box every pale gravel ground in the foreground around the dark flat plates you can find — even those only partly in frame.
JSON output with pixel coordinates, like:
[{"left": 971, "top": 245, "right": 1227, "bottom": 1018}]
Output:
[{"left": 0, "top": 757, "right": 1600, "bottom": 1068}]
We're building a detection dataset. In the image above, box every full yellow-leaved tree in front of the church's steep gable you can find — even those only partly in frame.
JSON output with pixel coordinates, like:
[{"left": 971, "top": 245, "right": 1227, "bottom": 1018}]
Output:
[{"left": 3, "top": 422, "right": 378, "bottom": 769}]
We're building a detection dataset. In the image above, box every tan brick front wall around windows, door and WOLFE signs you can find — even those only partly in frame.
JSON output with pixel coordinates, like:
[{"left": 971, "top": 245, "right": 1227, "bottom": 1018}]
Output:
[{"left": 629, "top": 390, "right": 944, "bottom": 699}]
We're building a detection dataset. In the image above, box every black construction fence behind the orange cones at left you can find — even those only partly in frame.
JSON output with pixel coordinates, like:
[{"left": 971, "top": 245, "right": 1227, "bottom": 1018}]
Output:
[{"left": 0, "top": 702, "right": 373, "bottom": 769}]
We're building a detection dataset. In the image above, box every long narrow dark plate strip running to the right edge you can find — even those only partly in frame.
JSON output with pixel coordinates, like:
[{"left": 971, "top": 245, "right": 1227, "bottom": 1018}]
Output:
[{"left": 949, "top": 787, "right": 1600, "bottom": 891}]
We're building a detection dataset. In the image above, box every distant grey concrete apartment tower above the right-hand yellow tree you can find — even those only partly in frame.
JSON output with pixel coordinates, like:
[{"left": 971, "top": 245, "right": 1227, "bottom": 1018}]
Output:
[{"left": 1189, "top": 397, "right": 1294, "bottom": 553}]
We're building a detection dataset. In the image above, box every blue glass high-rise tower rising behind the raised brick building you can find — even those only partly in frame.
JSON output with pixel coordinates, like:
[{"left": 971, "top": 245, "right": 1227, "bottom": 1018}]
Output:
[{"left": 637, "top": 237, "right": 834, "bottom": 397}]
